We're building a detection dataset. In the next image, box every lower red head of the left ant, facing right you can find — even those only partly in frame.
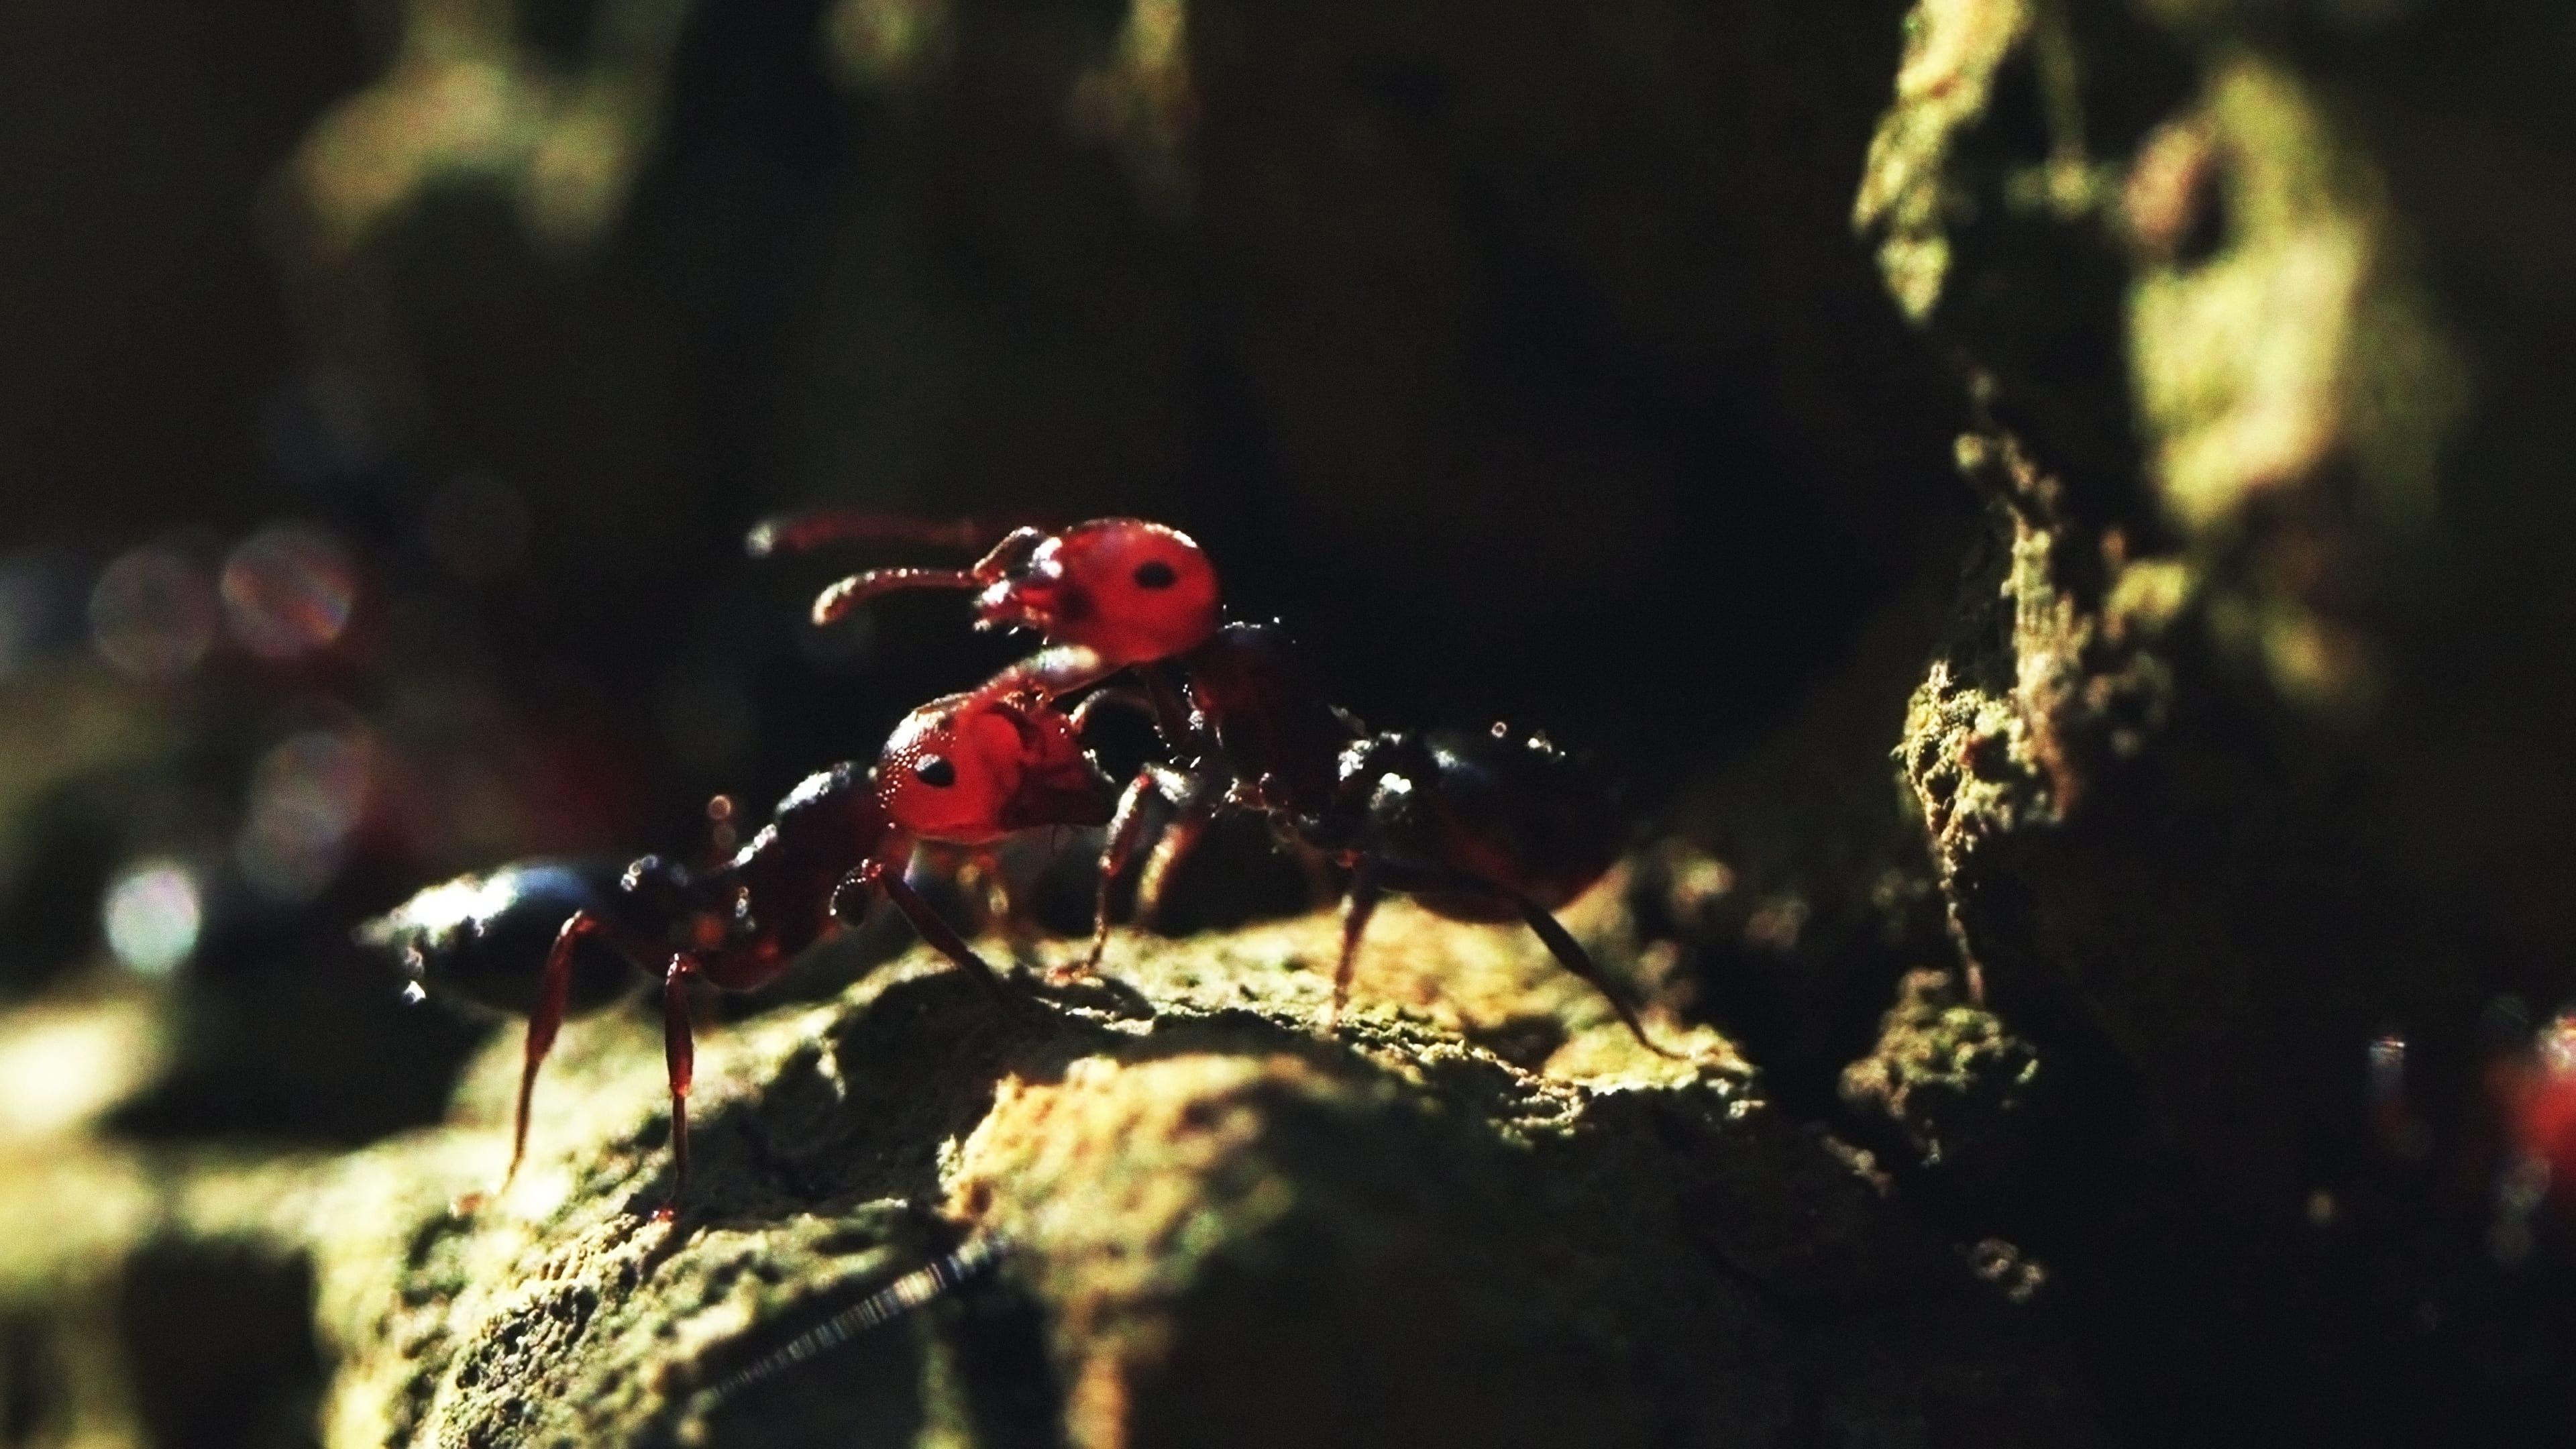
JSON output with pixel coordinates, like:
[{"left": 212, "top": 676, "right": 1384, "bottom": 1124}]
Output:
[{"left": 876, "top": 694, "right": 1110, "bottom": 846}]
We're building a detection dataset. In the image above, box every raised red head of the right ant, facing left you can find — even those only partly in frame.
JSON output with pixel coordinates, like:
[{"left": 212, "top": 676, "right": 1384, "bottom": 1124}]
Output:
[{"left": 976, "top": 519, "right": 1218, "bottom": 665}]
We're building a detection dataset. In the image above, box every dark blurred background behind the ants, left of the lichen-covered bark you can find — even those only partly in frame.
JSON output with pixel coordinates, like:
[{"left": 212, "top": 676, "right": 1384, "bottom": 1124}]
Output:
[{"left": 0, "top": 0, "right": 1966, "bottom": 1137}]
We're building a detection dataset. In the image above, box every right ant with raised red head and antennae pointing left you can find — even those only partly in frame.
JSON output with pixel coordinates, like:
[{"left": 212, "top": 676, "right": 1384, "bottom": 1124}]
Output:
[{"left": 752, "top": 513, "right": 1672, "bottom": 1057}]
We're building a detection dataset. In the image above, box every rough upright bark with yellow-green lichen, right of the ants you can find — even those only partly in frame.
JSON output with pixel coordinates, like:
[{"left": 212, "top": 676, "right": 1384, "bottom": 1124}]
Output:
[{"left": 1847, "top": 3, "right": 2576, "bottom": 1441}]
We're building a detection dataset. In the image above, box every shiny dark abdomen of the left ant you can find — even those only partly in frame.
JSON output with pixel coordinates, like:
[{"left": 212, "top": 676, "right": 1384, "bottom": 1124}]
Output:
[{"left": 358, "top": 859, "right": 641, "bottom": 1016}]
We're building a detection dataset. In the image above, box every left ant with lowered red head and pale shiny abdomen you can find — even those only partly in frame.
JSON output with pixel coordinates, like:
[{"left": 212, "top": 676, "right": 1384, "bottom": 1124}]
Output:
[{"left": 361, "top": 694, "right": 1110, "bottom": 1217}]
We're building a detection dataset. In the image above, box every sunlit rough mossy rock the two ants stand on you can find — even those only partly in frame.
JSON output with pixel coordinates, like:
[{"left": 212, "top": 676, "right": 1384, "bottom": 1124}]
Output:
[{"left": 272, "top": 908, "right": 2089, "bottom": 1446}]
